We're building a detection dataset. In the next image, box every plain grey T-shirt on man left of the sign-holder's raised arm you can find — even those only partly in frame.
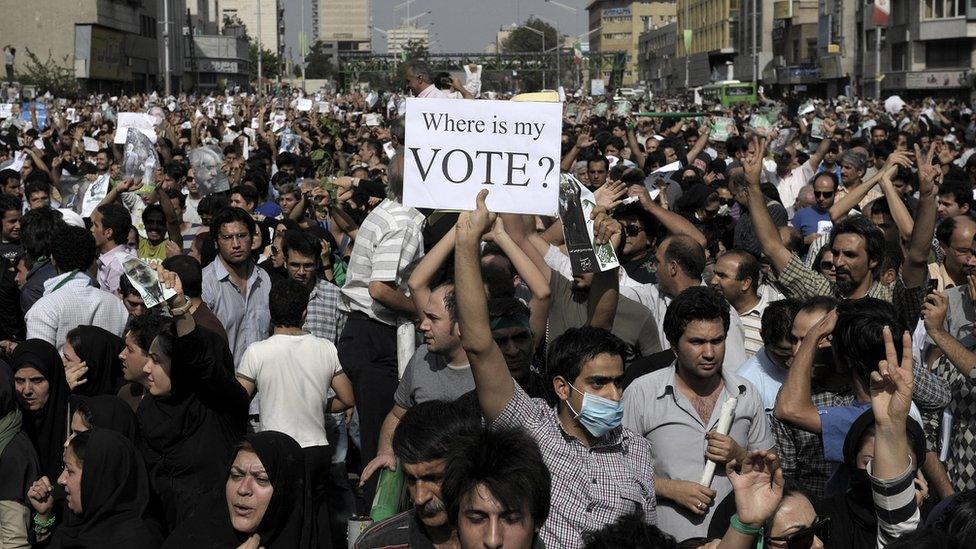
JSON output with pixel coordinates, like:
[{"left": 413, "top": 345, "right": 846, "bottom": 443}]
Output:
[{"left": 393, "top": 345, "right": 474, "bottom": 410}]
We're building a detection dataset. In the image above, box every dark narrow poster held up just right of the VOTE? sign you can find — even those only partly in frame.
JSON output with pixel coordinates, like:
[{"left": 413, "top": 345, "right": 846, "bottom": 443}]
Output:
[{"left": 559, "top": 173, "right": 620, "bottom": 275}]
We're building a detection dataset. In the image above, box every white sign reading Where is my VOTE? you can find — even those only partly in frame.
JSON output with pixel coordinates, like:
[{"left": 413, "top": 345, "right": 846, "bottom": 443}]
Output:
[{"left": 403, "top": 98, "right": 562, "bottom": 215}]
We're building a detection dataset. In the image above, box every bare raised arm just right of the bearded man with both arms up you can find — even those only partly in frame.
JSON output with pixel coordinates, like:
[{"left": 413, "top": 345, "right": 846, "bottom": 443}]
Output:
[{"left": 904, "top": 145, "right": 942, "bottom": 288}]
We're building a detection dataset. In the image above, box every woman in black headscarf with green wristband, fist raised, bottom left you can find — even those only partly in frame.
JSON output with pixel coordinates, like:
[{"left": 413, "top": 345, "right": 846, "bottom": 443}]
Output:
[{"left": 31, "top": 429, "right": 161, "bottom": 549}]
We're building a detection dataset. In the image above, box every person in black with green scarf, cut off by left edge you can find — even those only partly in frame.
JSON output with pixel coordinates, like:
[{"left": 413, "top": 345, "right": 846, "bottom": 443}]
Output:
[{"left": 0, "top": 362, "right": 39, "bottom": 547}]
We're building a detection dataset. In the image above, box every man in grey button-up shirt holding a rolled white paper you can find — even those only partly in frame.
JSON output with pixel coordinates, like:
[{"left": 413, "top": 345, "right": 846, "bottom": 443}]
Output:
[{"left": 623, "top": 286, "right": 774, "bottom": 539}]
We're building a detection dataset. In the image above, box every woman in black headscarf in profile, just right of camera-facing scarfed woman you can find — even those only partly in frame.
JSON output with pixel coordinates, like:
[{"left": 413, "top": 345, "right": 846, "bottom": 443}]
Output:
[{"left": 62, "top": 326, "right": 125, "bottom": 396}]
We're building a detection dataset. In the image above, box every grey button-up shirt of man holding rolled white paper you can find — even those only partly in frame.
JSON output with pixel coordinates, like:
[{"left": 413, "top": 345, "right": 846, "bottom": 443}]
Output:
[{"left": 623, "top": 364, "right": 774, "bottom": 539}]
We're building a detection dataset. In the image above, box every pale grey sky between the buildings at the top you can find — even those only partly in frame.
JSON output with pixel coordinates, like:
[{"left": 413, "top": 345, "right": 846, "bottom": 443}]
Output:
[{"left": 283, "top": 0, "right": 587, "bottom": 57}]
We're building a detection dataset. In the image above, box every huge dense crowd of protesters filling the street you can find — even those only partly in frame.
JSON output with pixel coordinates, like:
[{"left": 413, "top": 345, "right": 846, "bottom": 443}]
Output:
[{"left": 0, "top": 57, "right": 976, "bottom": 549}]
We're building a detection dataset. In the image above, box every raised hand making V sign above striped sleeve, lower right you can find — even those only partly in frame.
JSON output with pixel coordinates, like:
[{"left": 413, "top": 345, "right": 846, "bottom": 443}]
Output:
[{"left": 871, "top": 326, "right": 915, "bottom": 426}]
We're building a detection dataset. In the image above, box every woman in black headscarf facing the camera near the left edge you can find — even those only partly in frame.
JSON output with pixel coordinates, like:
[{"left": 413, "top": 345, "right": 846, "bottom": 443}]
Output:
[{"left": 10, "top": 339, "right": 69, "bottom": 479}]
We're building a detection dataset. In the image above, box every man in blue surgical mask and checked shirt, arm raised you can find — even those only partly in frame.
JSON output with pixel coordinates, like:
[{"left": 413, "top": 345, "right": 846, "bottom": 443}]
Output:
[{"left": 454, "top": 191, "right": 657, "bottom": 549}]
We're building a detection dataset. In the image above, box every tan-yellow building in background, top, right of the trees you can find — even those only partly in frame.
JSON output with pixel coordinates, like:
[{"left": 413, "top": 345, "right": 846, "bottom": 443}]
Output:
[{"left": 586, "top": 0, "right": 675, "bottom": 86}]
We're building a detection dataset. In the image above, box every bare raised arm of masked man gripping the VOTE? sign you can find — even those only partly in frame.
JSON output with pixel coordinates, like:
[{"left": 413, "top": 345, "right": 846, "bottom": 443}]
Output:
[{"left": 454, "top": 189, "right": 515, "bottom": 423}]
